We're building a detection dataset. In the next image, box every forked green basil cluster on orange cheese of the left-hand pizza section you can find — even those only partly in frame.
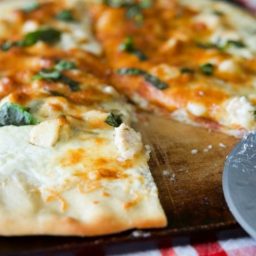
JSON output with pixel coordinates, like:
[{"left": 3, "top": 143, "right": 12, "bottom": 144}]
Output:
[{"left": 33, "top": 60, "right": 80, "bottom": 92}]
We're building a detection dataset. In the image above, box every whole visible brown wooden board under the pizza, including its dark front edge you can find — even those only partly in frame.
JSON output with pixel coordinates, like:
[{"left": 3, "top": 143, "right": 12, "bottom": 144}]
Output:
[{"left": 0, "top": 113, "right": 238, "bottom": 254}]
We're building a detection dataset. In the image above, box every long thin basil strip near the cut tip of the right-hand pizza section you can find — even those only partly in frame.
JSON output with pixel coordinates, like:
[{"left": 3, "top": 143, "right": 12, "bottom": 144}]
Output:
[{"left": 117, "top": 68, "right": 168, "bottom": 90}]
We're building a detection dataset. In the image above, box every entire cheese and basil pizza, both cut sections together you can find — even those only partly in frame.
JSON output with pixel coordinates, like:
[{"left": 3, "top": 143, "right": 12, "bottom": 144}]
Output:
[{"left": 0, "top": 0, "right": 256, "bottom": 236}]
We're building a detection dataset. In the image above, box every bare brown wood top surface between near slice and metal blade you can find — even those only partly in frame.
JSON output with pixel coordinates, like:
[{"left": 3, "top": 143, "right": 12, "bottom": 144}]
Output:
[{"left": 138, "top": 114, "right": 238, "bottom": 229}]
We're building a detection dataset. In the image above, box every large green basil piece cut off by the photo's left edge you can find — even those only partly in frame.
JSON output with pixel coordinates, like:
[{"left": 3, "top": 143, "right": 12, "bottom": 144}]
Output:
[{"left": 0, "top": 103, "right": 37, "bottom": 126}]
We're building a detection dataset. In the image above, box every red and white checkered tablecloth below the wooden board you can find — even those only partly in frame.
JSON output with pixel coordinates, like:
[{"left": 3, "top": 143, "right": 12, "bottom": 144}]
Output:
[{"left": 66, "top": 229, "right": 256, "bottom": 256}]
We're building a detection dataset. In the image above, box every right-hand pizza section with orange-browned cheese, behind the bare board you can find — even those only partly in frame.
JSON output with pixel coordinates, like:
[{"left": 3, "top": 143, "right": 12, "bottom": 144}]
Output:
[{"left": 87, "top": 0, "right": 256, "bottom": 136}]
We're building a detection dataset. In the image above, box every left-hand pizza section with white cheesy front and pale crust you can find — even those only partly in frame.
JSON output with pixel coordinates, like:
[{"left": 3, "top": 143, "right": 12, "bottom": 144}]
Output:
[{"left": 0, "top": 1, "right": 166, "bottom": 236}]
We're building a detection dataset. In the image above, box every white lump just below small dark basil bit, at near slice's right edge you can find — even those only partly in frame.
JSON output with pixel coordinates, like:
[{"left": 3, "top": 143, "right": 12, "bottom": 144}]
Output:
[{"left": 114, "top": 124, "right": 142, "bottom": 161}]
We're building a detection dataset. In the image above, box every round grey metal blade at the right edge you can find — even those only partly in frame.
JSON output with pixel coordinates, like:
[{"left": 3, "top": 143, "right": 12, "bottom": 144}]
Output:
[{"left": 222, "top": 133, "right": 256, "bottom": 239}]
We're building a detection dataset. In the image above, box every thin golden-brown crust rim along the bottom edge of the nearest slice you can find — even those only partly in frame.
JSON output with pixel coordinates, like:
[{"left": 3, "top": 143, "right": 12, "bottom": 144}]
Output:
[{"left": 0, "top": 216, "right": 166, "bottom": 236}]
